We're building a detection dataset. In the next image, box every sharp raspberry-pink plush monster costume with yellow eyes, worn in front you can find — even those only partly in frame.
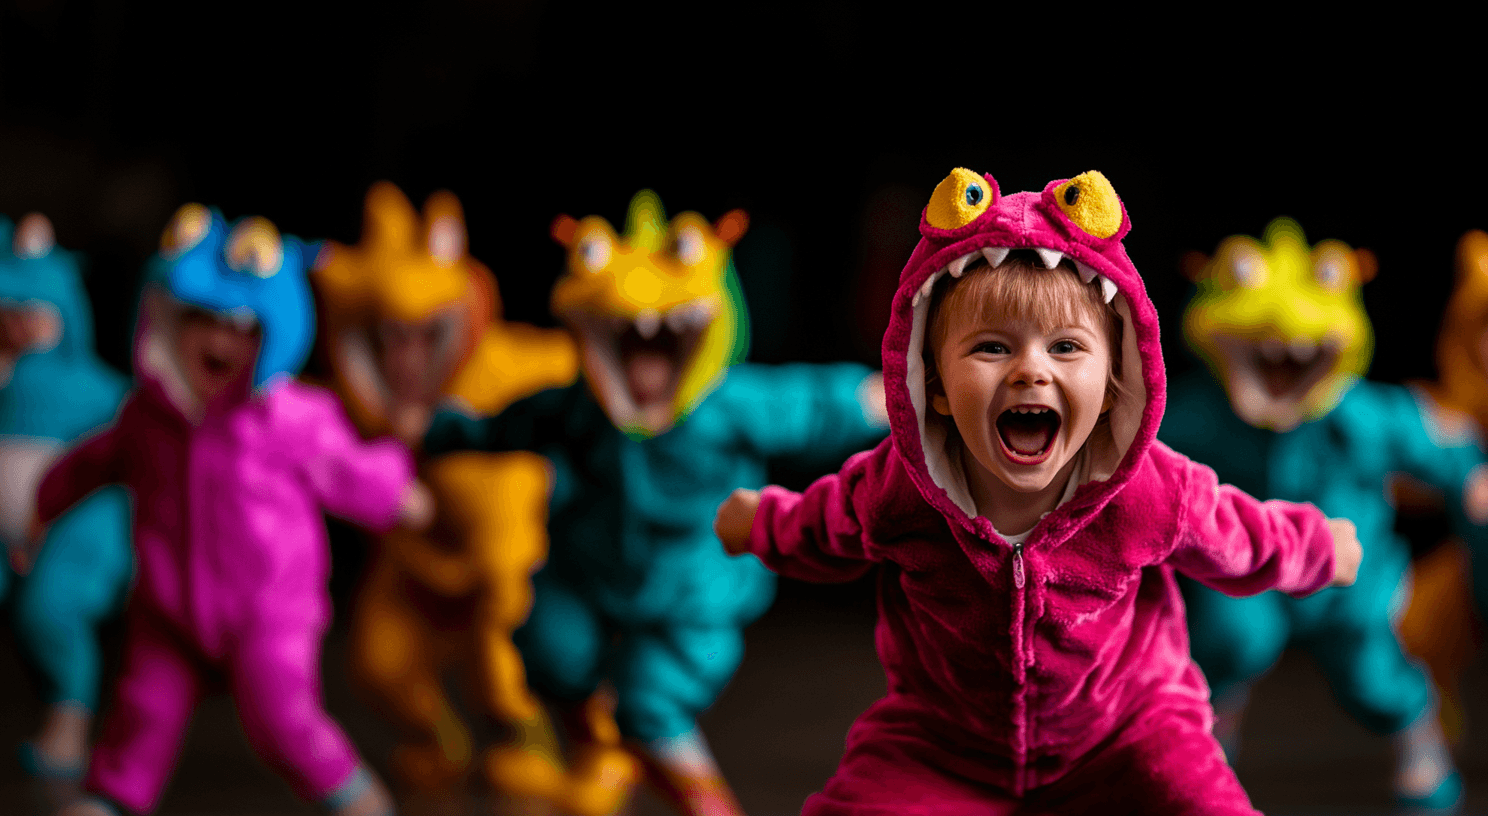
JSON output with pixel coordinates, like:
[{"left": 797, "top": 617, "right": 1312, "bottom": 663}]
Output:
[{"left": 750, "top": 170, "right": 1333, "bottom": 816}]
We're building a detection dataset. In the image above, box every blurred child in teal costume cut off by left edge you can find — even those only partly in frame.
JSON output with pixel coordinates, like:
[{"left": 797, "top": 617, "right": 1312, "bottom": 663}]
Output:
[{"left": 0, "top": 213, "right": 132, "bottom": 779}]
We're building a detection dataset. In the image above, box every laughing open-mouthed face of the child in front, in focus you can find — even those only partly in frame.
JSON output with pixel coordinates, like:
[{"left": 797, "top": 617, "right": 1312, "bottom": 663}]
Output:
[{"left": 930, "top": 272, "right": 1112, "bottom": 496}]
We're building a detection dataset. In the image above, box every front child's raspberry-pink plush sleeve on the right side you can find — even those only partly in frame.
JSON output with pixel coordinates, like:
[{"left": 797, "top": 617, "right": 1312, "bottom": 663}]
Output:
[{"left": 1170, "top": 454, "right": 1333, "bottom": 597}]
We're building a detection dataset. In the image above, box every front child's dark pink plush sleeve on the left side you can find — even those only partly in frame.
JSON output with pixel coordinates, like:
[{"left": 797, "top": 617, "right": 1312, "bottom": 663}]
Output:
[{"left": 748, "top": 461, "right": 873, "bottom": 584}]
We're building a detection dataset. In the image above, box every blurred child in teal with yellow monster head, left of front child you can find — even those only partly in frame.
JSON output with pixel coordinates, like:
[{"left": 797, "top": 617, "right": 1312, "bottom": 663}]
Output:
[{"left": 424, "top": 191, "right": 887, "bottom": 816}]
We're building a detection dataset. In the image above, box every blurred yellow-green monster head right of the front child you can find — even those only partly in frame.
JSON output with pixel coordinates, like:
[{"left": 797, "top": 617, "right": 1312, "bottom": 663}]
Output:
[{"left": 1183, "top": 217, "right": 1375, "bottom": 432}]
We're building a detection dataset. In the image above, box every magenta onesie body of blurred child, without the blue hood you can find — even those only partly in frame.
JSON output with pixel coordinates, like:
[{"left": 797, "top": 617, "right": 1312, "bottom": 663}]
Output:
[{"left": 37, "top": 296, "right": 414, "bottom": 813}]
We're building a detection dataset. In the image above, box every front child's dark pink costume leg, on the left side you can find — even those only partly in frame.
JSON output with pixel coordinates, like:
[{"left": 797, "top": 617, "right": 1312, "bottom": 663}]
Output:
[{"left": 801, "top": 701, "right": 1018, "bottom": 816}]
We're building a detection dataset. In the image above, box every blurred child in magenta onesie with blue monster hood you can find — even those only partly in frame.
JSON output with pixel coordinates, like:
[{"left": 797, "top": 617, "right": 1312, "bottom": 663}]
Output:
[{"left": 18, "top": 204, "right": 432, "bottom": 816}]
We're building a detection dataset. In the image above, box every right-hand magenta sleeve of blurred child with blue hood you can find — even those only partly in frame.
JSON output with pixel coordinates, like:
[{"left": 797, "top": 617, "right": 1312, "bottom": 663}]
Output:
[{"left": 302, "top": 393, "right": 414, "bottom": 532}]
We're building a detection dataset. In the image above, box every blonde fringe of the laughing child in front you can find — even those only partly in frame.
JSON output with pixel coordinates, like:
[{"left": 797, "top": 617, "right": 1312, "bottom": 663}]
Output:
[{"left": 924, "top": 250, "right": 1125, "bottom": 410}]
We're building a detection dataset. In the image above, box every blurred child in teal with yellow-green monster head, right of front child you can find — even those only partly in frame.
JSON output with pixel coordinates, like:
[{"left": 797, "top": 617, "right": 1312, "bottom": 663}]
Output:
[{"left": 1159, "top": 219, "right": 1488, "bottom": 809}]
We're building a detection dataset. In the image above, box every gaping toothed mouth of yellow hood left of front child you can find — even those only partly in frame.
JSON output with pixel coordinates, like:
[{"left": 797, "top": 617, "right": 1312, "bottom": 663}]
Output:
[{"left": 559, "top": 298, "right": 720, "bottom": 426}]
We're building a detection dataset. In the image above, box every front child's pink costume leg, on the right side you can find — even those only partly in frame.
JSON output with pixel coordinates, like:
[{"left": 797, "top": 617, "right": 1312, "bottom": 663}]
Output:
[{"left": 1028, "top": 699, "right": 1260, "bottom": 816}]
